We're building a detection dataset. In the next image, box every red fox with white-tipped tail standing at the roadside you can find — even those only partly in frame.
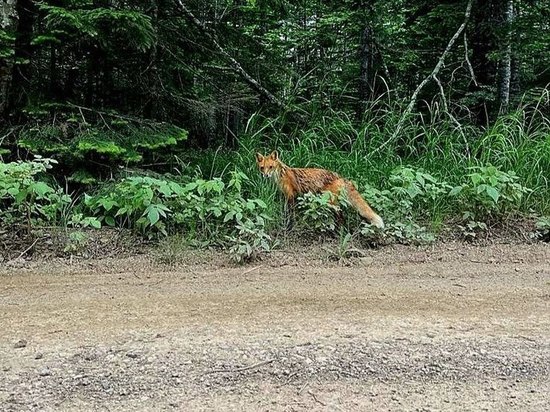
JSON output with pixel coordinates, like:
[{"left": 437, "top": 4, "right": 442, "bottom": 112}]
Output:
[{"left": 256, "top": 151, "right": 384, "bottom": 228}]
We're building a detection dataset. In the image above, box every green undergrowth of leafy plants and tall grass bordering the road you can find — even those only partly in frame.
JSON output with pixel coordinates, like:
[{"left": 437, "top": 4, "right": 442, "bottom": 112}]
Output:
[{"left": 0, "top": 94, "right": 550, "bottom": 262}]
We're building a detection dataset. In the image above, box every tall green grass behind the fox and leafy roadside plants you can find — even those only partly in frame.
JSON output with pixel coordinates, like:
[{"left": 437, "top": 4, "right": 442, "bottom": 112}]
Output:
[{"left": 187, "top": 90, "right": 550, "bottom": 229}]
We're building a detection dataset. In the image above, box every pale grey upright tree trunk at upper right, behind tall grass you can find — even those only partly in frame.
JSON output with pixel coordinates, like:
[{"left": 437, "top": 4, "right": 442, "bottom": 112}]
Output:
[{"left": 498, "top": 0, "right": 514, "bottom": 114}]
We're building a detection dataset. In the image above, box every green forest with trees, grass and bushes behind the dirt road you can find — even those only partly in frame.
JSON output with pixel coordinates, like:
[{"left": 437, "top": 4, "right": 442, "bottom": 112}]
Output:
[{"left": 0, "top": 0, "right": 550, "bottom": 261}]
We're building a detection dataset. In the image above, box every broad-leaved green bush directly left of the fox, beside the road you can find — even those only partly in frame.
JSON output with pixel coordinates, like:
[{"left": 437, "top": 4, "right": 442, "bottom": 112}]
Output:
[{"left": 85, "top": 168, "right": 272, "bottom": 262}]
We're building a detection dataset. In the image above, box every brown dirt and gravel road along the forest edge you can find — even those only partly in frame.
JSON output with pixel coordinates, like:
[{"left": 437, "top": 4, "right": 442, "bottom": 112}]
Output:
[{"left": 0, "top": 244, "right": 550, "bottom": 411}]
